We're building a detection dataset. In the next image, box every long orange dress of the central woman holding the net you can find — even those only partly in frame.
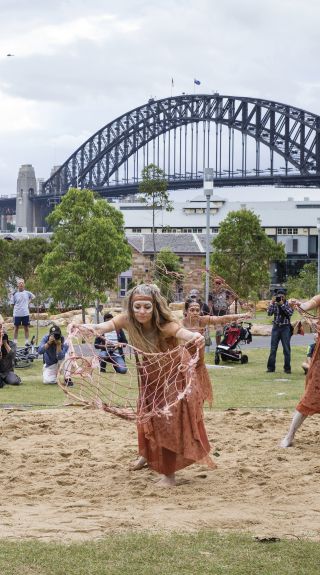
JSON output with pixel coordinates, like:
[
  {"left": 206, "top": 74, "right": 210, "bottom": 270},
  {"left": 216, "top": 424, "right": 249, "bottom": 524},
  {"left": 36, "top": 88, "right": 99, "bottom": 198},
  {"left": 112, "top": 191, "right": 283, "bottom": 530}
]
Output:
[{"left": 113, "top": 316, "right": 216, "bottom": 475}]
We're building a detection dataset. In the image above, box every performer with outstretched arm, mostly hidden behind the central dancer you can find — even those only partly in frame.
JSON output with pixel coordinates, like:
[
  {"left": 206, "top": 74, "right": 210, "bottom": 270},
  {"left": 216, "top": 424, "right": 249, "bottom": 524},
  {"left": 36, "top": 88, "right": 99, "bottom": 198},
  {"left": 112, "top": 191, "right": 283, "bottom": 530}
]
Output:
[{"left": 182, "top": 298, "right": 251, "bottom": 404}]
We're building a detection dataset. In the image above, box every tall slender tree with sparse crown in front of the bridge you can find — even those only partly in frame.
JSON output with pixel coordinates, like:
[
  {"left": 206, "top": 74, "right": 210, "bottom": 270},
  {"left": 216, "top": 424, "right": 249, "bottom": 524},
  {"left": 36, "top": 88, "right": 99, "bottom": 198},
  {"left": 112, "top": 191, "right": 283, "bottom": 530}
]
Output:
[{"left": 139, "top": 164, "right": 173, "bottom": 257}]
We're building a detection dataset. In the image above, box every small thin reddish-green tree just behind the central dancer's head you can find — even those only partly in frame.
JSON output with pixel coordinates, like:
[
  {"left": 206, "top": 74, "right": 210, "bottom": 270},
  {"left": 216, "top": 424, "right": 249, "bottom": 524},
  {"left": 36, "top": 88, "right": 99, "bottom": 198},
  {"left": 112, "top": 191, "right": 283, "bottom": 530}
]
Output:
[{"left": 154, "top": 248, "right": 182, "bottom": 301}]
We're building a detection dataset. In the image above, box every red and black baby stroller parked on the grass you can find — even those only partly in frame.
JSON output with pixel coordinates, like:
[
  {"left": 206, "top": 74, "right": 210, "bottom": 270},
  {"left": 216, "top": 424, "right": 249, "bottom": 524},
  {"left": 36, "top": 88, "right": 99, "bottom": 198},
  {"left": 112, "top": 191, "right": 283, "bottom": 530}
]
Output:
[{"left": 214, "top": 322, "right": 252, "bottom": 365}]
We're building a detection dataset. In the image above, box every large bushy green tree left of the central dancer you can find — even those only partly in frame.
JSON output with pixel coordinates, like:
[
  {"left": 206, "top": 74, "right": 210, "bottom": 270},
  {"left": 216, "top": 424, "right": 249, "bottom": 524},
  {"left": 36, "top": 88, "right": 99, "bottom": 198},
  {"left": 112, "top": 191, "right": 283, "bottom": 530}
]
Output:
[{"left": 37, "top": 188, "right": 131, "bottom": 321}]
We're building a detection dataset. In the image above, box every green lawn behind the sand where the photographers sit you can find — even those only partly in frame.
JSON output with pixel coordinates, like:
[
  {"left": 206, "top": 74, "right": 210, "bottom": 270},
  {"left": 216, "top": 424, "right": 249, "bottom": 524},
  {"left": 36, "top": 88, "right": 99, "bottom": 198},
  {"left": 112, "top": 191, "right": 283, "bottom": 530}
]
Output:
[{"left": 0, "top": 346, "right": 307, "bottom": 410}]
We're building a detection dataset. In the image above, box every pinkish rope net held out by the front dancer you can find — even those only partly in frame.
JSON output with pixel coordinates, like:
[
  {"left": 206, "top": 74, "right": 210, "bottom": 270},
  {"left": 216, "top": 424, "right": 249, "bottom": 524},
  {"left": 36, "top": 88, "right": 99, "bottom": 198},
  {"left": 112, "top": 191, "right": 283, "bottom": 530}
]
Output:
[{"left": 58, "top": 326, "right": 199, "bottom": 423}]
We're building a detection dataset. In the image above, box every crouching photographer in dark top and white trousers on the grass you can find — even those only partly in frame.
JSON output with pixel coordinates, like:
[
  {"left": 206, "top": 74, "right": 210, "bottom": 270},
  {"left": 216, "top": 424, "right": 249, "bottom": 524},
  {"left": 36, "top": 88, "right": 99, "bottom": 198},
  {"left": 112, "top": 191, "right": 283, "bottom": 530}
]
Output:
[{"left": 38, "top": 325, "right": 72, "bottom": 386}]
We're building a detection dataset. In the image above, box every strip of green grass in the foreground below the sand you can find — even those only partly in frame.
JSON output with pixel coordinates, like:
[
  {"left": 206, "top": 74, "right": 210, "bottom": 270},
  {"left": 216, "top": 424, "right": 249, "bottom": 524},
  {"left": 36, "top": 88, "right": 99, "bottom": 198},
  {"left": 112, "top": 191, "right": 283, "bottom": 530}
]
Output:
[{"left": 0, "top": 532, "right": 320, "bottom": 575}]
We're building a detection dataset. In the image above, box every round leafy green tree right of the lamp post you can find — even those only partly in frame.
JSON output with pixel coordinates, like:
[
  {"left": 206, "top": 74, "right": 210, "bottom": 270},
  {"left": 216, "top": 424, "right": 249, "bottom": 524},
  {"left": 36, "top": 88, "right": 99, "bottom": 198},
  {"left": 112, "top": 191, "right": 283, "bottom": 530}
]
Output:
[{"left": 211, "top": 210, "right": 285, "bottom": 298}]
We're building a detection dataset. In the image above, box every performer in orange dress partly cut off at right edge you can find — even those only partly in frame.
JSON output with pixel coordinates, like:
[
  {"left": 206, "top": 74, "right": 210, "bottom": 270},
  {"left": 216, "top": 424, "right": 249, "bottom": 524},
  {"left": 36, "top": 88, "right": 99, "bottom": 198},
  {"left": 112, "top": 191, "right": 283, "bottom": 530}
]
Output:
[{"left": 280, "top": 294, "right": 320, "bottom": 447}]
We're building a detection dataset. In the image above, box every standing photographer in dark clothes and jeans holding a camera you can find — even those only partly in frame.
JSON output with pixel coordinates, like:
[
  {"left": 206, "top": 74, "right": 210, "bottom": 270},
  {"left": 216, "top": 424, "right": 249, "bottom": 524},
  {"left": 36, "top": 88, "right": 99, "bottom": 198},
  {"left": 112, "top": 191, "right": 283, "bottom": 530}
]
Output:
[{"left": 267, "top": 288, "right": 293, "bottom": 373}]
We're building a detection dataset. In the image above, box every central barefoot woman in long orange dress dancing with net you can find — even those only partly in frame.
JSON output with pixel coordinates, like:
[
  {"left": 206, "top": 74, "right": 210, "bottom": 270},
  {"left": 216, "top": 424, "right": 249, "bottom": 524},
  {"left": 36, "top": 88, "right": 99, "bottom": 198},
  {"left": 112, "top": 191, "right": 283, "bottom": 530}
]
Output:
[{"left": 81, "top": 284, "right": 215, "bottom": 487}]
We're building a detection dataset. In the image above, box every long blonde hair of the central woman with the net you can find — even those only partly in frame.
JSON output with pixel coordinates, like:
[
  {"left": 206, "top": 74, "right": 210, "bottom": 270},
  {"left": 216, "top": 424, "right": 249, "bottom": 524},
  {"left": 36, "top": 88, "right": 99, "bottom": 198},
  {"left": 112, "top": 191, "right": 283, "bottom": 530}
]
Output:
[{"left": 128, "top": 284, "right": 176, "bottom": 353}]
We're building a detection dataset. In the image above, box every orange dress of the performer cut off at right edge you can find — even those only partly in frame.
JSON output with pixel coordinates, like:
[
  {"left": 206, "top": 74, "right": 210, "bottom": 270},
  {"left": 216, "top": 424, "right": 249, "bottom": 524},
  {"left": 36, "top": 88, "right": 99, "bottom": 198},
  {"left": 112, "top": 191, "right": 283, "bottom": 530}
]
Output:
[{"left": 296, "top": 330, "right": 320, "bottom": 416}]
